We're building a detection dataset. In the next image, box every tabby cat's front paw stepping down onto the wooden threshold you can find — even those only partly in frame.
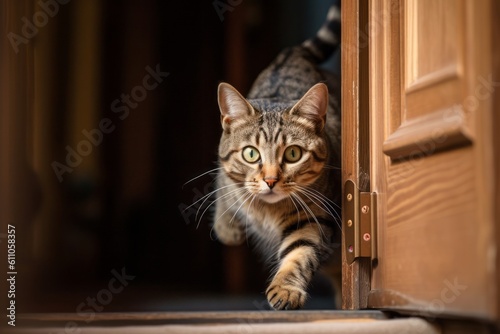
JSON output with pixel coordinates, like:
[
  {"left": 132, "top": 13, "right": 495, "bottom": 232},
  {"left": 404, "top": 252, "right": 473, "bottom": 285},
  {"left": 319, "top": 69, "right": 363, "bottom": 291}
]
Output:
[{"left": 266, "top": 284, "right": 307, "bottom": 310}]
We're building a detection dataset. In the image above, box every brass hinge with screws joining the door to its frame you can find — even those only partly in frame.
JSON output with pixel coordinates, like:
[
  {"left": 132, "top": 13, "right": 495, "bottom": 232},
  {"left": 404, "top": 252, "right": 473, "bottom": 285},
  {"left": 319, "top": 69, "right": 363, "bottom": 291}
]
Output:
[{"left": 342, "top": 180, "right": 377, "bottom": 264}]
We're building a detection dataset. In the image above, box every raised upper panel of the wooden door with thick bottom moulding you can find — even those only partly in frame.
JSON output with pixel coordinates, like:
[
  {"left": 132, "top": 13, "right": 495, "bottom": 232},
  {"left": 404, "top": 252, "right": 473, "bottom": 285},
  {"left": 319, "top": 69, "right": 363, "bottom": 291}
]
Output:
[{"left": 383, "top": 0, "right": 473, "bottom": 159}]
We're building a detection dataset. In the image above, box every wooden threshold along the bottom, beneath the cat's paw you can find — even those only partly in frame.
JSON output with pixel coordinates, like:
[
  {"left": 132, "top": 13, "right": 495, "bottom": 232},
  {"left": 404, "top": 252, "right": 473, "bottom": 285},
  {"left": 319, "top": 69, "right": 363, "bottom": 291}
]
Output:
[{"left": 4, "top": 311, "right": 441, "bottom": 334}]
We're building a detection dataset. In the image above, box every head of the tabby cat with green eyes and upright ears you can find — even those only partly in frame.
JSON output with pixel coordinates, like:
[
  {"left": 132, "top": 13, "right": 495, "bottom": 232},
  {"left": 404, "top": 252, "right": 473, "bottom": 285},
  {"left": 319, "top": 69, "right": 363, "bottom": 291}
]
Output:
[{"left": 218, "top": 83, "right": 328, "bottom": 203}]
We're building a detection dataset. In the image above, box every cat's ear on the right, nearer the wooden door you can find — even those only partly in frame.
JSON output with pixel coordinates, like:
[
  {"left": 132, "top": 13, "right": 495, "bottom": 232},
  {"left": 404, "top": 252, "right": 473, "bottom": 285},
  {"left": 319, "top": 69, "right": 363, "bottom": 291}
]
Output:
[{"left": 290, "top": 83, "right": 328, "bottom": 131}]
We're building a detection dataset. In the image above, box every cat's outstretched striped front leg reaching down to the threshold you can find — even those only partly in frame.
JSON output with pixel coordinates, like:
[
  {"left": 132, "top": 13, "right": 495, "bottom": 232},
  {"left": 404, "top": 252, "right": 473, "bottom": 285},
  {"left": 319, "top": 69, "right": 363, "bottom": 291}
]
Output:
[{"left": 266, "top": 222, "right": 330, "bottom": 310}]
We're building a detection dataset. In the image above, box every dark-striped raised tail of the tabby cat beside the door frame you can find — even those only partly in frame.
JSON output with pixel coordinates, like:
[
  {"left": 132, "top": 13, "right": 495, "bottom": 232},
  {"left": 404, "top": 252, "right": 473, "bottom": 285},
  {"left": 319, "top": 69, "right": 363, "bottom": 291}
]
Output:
[{"left": 302, "top": 0, "right": 340, "bottom": 63}]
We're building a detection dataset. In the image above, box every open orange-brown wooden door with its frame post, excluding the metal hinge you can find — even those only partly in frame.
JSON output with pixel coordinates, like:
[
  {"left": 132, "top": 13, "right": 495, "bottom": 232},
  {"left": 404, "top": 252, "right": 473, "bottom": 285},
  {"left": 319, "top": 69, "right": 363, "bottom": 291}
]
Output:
[{"left": 342, "top": 0, "right": 500, "bottom": 321}]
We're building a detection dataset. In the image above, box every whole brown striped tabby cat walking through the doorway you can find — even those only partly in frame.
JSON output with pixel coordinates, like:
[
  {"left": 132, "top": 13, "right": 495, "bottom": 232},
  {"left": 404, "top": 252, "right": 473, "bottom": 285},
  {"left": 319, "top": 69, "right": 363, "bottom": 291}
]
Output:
[{"left": 213, "top": 5, "right": 341, "bottom": 310}]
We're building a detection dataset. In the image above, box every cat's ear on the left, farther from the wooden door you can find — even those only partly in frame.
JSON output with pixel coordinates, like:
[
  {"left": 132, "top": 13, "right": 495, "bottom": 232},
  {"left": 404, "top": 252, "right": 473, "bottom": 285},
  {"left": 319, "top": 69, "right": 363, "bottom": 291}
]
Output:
[{"left": 217, "top": 82, "right": 255, "bottom": 127}]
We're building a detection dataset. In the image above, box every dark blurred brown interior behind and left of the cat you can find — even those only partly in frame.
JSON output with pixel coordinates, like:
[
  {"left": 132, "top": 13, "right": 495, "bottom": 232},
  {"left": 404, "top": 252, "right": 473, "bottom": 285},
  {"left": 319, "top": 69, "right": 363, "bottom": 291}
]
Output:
[{"left": 0, "top": 0, "right": 338, "bottom": 312}]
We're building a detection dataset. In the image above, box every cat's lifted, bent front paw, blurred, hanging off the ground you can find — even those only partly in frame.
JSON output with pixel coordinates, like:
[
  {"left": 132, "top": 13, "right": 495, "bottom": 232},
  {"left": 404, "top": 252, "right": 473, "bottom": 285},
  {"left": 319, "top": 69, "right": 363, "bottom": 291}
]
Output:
[{"left": 213, "top": 203, "right": 246, "bottom": 246}]
